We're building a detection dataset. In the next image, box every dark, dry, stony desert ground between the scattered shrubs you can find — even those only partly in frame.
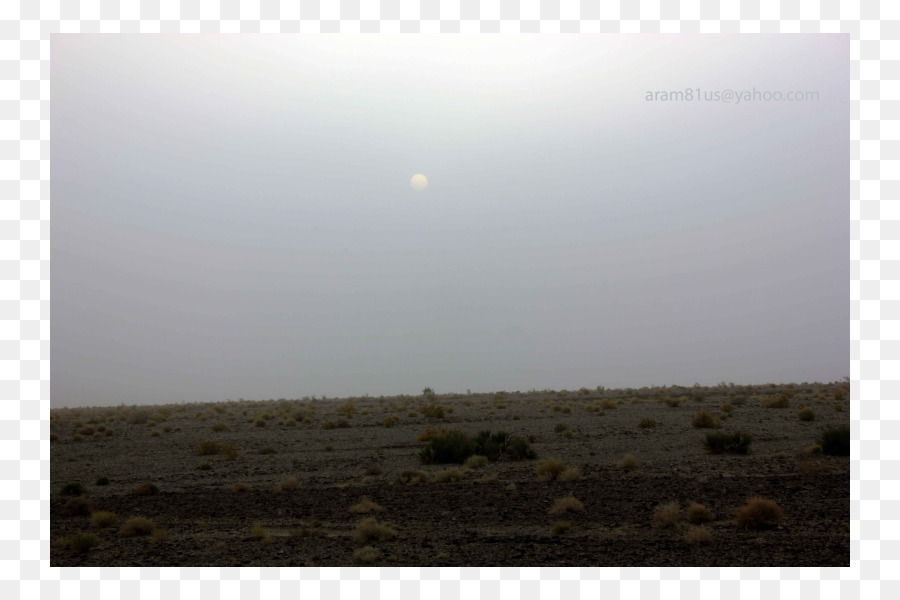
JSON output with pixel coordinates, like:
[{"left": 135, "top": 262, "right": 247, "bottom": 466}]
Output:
[{"left": 50, "top": 382, "right": 850, "bottom": 566}]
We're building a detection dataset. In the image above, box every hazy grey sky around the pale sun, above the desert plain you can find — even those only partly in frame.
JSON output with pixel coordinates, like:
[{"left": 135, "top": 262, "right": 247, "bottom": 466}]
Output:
[{"left": 51, "top": 35, "right": 850, "bottom": 406}]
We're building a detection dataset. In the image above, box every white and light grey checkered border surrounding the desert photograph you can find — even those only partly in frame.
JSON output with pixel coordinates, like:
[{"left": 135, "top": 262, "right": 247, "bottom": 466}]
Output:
[{"left": 0, "top": 0, "right": 888, "bottom": 600}]
